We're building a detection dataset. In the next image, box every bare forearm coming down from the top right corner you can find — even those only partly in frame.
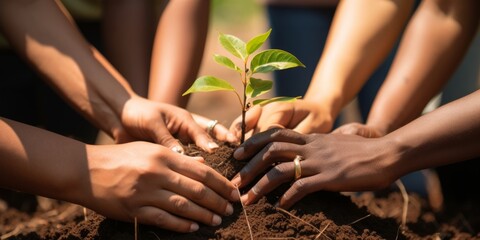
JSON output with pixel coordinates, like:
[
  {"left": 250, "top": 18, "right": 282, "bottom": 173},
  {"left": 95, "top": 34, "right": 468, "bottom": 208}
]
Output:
[{"left": 367, "top": 0, "right": 480, "bottom": 133}]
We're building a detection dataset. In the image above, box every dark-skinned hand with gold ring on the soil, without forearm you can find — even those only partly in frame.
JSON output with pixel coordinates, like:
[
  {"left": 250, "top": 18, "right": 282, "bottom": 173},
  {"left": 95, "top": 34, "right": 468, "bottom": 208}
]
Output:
[{"left": 232, "top": 129, "right": 401, "bottom": 208}]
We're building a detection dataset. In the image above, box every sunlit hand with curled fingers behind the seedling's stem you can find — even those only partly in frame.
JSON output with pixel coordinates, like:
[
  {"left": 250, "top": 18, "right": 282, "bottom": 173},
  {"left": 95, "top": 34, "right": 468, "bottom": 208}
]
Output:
[{"left": 230, "top": 100, "right": 333, "bottom": 141}]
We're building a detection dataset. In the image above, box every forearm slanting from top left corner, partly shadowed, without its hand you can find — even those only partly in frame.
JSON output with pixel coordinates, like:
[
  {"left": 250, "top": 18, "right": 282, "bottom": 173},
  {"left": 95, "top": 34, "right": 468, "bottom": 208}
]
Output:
[{"left": 0, "top": 0, "right": 134, "bottom": 137}]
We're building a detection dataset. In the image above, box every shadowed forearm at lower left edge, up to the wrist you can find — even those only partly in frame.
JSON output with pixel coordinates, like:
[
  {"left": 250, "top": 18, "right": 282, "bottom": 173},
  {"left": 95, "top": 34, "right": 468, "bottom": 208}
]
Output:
[{"left": 0, "top": 118, "right": 88, "bottom": 204}]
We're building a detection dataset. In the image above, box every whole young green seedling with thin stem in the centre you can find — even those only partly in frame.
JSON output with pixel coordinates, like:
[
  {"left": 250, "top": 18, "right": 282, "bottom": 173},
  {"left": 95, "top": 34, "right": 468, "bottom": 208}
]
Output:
[{"left": 182, "top": 29, "right": 305, "bottom": 143}]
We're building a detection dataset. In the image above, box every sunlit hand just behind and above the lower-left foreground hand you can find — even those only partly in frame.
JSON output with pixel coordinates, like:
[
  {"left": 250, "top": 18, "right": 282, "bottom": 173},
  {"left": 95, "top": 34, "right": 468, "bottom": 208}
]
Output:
[{"left": 114, "top": 97, "right": 218, "bottom": 152}]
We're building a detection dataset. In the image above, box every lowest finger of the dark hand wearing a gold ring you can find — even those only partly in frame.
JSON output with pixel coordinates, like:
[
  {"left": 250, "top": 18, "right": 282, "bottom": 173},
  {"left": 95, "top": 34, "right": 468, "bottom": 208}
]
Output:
[{"left": 278, "top": 175, "right": 323, "bottom": 209}]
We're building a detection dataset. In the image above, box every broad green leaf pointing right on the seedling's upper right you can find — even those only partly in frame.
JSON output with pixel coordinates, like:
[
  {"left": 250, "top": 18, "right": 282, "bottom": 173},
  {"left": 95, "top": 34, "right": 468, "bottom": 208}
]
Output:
[{"left": 250, "top": 49, "right": 305, "bottom": 73}]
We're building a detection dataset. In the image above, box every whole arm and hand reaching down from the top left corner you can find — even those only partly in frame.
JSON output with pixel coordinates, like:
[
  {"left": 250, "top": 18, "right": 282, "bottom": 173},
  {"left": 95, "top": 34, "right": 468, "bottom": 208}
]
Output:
[{"left": 0, "top": 0, "right": 216, "bottom": 151}]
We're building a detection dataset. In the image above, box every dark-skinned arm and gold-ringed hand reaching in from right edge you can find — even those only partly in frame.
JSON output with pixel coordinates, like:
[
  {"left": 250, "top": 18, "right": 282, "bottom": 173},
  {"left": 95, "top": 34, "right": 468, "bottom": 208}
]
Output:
[{"left": 232, "top": 90, "right": 480, "bottom": 208}]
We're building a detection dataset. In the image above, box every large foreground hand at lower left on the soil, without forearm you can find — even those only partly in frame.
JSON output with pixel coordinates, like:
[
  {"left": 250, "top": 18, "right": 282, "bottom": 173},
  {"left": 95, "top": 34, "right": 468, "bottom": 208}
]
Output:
[{"left": 83, "top": 142, "right": 238, "bottom": 232}]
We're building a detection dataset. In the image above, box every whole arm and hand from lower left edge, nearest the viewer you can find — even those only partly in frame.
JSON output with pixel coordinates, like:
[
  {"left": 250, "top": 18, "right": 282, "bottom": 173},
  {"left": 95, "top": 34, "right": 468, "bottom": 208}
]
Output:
[{"left": 0, "top": 118, "right": 238, "bottom": 232}]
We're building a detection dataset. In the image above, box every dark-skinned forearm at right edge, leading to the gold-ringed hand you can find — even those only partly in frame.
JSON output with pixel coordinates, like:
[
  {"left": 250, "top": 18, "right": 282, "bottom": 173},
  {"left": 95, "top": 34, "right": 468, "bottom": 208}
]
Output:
[{"left": 385, "top": 90, "right": 480, "bottom": 178}]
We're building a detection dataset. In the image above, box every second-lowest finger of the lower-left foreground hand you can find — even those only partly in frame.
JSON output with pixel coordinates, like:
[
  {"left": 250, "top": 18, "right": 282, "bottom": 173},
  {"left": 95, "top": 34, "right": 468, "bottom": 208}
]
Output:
[{"left": 150, "top": 190, "right": 222, "bottom": 226}]
